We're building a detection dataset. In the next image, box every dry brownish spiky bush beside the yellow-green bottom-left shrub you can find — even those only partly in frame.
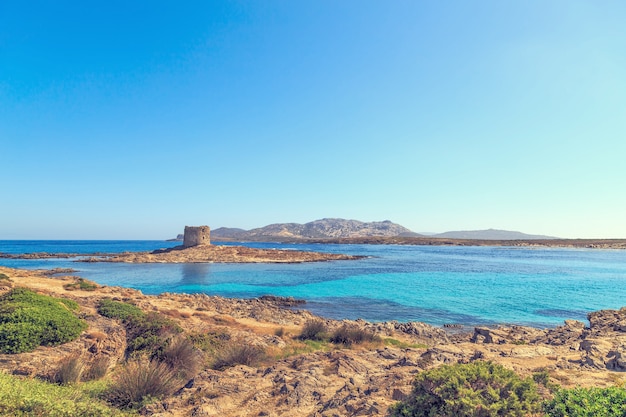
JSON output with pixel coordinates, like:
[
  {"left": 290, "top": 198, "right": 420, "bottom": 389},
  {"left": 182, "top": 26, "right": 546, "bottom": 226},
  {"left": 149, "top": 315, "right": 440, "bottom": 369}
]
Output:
[{"left": 106, "top": 361, "right": 180, "bottom": 409}]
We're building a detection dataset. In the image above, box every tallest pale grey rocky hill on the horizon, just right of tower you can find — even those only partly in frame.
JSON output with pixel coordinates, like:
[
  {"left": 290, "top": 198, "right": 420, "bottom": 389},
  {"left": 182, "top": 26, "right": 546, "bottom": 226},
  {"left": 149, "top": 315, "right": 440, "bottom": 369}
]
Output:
[{"left": 211, "top": 219, "right": 420, "bottom": 241}]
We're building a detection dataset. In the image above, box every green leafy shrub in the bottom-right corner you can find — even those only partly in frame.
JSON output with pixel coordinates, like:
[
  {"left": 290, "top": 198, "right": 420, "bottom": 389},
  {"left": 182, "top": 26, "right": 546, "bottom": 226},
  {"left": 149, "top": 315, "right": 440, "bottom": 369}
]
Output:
[{"left": 544, "top": 387, "right": 626, "bottom": 417}]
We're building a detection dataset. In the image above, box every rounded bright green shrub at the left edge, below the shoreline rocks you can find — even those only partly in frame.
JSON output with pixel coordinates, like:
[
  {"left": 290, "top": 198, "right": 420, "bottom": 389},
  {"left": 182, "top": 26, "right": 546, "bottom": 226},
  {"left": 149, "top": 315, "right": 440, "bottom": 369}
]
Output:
[{"left": 0, "top": 288, "right": 87, "bottom": 353}]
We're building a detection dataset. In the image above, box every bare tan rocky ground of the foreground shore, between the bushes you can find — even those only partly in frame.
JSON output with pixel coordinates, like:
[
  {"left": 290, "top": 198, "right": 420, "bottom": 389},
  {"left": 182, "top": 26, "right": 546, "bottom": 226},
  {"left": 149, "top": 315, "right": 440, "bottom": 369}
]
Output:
[{"left": 0, "top": 267, "right": 626, "bottom": 417}]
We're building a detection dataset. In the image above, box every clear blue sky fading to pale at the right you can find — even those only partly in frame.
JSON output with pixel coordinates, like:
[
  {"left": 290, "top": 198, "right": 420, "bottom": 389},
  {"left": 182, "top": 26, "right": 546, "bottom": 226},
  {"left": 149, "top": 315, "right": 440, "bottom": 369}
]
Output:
[{"left": 0, "top": 0, "right": 626, "bottom": 239}]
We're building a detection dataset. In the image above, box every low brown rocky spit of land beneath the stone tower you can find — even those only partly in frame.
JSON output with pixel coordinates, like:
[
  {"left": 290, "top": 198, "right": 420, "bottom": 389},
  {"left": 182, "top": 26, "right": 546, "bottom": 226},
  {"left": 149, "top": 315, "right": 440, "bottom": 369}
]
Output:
[{"left": 0, "top": 245, "right": 363, "bottom": 263}]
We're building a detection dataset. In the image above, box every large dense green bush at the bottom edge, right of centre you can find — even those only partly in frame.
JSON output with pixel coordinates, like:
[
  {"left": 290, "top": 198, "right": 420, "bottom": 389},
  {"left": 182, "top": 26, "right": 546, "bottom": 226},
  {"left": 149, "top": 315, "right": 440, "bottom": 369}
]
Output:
[{"left": 390, "top": 362, "right": 541, "bottom": 417}]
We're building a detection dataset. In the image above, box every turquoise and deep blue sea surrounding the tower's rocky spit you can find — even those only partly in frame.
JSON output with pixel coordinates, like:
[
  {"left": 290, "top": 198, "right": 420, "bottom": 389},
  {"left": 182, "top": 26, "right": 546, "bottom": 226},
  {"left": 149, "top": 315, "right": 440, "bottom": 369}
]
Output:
[{"left": 0, "top": 240, "right": 626, "bottom": 328}]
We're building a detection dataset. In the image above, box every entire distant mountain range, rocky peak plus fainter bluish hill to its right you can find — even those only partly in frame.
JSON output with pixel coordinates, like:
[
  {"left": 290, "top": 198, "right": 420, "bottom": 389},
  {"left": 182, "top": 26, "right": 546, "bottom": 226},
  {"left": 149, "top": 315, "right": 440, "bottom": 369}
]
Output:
[{"left": 211, "top": 218, "right": 556, "bottom": 241}]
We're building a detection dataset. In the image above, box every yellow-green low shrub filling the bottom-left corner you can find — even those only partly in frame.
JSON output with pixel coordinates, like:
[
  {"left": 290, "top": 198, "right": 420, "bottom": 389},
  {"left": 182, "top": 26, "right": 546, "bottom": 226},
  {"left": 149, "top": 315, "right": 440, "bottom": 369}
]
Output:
[{"left": 0, "top": 372, "right": 127, "bottom": 417}]
